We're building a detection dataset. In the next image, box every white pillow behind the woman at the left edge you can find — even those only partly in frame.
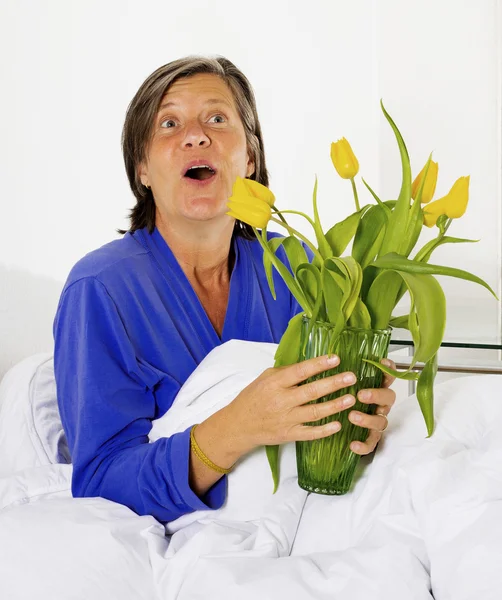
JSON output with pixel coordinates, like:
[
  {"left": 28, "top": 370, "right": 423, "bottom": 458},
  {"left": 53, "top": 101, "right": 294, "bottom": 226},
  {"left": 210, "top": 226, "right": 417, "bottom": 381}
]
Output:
[{"left": 0, "top": 353, "right": 70, "bottom": 477}]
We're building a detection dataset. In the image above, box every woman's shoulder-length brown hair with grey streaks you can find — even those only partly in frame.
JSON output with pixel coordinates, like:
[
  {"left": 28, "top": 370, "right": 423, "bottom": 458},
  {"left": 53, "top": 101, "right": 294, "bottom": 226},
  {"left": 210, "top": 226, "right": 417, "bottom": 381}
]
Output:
[{"left": 119, "top": 56, "right": 268, "bottom": 239}]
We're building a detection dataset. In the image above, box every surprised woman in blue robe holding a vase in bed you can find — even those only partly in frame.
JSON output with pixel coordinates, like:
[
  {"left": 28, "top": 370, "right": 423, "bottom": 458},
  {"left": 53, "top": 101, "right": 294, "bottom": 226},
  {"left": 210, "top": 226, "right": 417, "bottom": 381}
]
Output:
[{"left": 54, "top": 57, "right": 395, "bottom": 521}]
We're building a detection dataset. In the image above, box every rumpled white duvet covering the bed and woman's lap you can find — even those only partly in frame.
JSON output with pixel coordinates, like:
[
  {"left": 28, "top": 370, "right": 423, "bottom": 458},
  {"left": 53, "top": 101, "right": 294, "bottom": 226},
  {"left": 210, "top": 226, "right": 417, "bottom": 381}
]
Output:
[{"left": 0, "top": 340, "right": 502, "bottom": 600}]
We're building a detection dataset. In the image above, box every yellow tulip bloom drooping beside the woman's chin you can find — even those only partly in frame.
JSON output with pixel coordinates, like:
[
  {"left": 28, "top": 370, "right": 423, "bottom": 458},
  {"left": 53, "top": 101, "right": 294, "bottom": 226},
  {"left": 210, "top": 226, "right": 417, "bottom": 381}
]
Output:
[{"left": 227, "top": 177, "right": 275, "bottom": 228}]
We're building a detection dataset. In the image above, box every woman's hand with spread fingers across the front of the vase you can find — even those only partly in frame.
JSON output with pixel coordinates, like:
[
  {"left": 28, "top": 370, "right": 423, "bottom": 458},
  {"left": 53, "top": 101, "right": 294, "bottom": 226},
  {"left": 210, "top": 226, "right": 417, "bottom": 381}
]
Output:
[{"left": 224, "top": 356, "right": 355, "bottom": 455}]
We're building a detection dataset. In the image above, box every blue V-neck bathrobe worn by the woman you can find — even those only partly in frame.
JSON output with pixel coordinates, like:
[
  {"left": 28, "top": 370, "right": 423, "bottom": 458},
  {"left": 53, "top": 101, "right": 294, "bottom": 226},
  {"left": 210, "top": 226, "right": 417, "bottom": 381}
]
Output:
[{"left": 54, "top": 228, "right": 300, "bottom": 521}]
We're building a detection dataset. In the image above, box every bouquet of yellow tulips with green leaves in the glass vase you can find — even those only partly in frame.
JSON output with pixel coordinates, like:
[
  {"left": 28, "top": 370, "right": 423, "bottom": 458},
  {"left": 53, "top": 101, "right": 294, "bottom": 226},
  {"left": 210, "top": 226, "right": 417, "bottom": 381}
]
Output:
[{"left": 228, "top": 103, "right": 497, "bottom": 490}]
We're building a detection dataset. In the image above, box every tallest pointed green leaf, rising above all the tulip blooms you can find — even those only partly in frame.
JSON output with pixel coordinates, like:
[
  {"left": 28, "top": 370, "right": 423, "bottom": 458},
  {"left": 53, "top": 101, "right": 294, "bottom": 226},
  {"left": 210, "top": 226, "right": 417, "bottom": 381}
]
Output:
[{"left": 380, "top": 102, "right": 411, "bottom": 255}]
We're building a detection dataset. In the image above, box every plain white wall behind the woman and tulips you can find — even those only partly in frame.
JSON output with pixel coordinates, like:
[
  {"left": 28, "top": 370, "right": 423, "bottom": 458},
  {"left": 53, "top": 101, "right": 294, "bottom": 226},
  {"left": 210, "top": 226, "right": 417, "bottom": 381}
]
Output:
[{"left": 0, "top": 0, "right": 502, "bottom": 377}]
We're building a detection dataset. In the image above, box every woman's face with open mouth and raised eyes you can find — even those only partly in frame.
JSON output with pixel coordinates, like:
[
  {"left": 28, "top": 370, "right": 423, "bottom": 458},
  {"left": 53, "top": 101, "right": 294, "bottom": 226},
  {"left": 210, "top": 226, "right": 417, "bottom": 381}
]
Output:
[{"left": 140, "top": 74, "right": 254, "bottom": 223}]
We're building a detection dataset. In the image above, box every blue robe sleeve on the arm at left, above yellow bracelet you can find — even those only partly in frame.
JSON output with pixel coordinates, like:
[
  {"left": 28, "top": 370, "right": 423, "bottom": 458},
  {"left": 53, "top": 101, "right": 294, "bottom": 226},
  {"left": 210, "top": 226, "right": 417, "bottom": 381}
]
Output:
[{"left": 54, "top": 277, "right": 227, "bottom": 522}]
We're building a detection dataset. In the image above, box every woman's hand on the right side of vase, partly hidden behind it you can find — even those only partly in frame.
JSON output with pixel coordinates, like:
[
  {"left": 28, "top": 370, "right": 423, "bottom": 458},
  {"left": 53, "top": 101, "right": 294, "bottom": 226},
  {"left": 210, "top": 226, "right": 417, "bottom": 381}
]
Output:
[{"left": 349, "top": 359, "right": 396, "bottom": 455}]
